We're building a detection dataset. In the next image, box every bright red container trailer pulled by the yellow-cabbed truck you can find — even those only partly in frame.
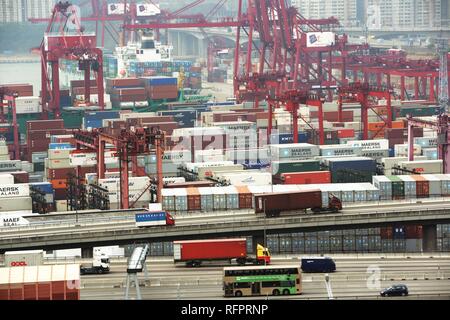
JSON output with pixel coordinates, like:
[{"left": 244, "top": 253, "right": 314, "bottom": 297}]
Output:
[{"left": 173, "top": 238, "right": 247, "bottom": 262}]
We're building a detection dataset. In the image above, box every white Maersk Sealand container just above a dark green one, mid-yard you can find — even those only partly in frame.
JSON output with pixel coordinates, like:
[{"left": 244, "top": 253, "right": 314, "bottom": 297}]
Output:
[{"left": 269, "top": 143, "right": 320, "bottom": 161}]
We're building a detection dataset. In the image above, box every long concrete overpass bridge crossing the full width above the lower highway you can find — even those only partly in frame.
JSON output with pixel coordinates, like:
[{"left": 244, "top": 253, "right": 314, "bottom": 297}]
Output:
[{"left": 0, "top": 203, "right": 450, "bottom": 252}]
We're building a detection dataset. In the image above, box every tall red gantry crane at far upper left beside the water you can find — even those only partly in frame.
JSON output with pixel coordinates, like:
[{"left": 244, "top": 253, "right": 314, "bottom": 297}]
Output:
[{"left": 40, "top": 2, "right": 104, "bottom": 119}]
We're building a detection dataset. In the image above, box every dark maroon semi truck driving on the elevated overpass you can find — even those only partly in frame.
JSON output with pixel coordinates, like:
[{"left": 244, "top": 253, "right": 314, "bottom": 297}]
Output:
[{"left": 255, "top": 189, "right": 342, "bottom": 217}]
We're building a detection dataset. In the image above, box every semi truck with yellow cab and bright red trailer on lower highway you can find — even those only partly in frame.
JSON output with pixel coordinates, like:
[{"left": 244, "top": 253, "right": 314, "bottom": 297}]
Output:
[{"left": 173, "top": 238, "right": 270, "bottom": 267}]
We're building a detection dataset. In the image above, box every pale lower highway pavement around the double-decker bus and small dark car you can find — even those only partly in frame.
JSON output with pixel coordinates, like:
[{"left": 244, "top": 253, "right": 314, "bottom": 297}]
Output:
[{"left": 77, "top": 254, "right": 450, "bottom": 300}]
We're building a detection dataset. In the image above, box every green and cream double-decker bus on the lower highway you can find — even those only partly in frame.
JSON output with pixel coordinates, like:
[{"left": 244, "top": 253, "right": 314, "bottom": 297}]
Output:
[{"left": 223, "top": 265, "right": 302, "bottom": 297}]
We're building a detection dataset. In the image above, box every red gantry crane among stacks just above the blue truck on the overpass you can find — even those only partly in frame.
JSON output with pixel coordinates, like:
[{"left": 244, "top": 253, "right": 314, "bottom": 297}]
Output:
[{"left": 74, "top": 127, "right": 165, "bottom": 209}]
